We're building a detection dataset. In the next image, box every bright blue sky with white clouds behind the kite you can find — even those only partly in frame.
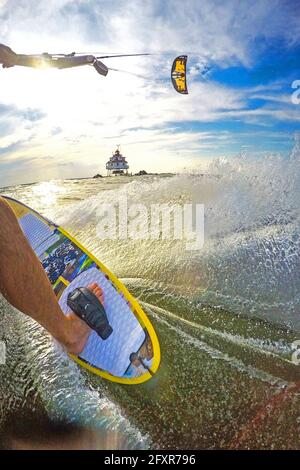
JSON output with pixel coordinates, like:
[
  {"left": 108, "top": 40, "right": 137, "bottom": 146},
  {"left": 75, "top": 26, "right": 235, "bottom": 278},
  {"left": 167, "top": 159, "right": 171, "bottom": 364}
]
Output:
[{"left": 0, "top": 0, "right": 300, "bottom": 187}]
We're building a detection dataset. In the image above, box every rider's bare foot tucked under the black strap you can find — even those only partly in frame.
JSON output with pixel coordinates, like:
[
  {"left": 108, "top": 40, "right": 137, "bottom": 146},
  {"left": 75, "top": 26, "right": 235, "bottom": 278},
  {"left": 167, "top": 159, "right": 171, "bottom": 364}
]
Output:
[{"left": 65, "top": 283, "right": 103, "bottom": 355}]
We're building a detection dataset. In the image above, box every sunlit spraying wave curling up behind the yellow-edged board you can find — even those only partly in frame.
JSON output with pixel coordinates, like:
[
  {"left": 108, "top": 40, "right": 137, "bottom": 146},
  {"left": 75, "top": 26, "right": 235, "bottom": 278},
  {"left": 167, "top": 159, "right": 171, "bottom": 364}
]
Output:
[{"left": 44, "top": 146, "right": 300, "bottom": 330}]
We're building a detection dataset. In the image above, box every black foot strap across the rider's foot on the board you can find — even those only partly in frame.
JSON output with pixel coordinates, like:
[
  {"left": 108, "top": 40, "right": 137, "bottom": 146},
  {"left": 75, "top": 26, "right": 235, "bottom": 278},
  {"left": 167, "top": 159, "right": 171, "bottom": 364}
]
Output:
[{"left": 67, "top": 287, "right": 113, "bottom": 339}]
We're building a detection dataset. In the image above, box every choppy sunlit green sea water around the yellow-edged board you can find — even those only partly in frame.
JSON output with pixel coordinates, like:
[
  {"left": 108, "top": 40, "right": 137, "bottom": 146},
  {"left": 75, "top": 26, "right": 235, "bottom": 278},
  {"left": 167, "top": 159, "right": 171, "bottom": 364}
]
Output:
[{"left": 0, "top": 147, "right": 300, "bottom": 449}]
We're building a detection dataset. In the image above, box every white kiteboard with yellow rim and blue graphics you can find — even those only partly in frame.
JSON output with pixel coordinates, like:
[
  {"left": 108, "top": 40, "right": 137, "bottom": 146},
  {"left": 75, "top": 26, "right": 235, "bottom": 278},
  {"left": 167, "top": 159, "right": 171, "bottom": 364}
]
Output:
[{"left": 5, "top": 197, "right": 160, "bottom": 384}]
